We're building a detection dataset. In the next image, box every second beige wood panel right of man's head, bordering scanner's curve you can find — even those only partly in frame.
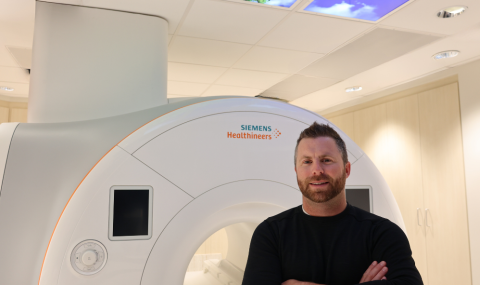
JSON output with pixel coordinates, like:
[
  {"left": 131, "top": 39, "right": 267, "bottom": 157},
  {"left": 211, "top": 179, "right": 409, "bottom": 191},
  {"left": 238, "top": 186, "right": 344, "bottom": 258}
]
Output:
[{"left": 353, "top": 104, "right": 390, "bottom": 176}]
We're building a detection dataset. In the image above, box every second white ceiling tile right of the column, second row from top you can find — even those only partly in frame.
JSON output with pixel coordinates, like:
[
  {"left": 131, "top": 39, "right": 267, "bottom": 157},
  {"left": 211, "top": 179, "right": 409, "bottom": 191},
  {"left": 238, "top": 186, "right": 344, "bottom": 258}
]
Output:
[{"left": 233, "top": 46, "right": 323, "bottom": 74}]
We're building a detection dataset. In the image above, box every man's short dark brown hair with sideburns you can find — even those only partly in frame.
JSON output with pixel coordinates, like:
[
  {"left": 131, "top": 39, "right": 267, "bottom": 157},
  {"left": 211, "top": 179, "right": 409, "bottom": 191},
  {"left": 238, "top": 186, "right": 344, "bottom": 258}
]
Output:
[{"left": 294, "top": 122, "right": 348, "bottom": 165}]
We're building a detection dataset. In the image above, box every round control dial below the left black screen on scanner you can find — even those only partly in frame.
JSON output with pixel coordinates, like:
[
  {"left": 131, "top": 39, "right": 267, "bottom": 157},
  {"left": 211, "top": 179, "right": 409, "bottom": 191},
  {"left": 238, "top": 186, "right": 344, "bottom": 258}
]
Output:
[{"left": 70, "top": 240, "right": 107, "bottom": 275}]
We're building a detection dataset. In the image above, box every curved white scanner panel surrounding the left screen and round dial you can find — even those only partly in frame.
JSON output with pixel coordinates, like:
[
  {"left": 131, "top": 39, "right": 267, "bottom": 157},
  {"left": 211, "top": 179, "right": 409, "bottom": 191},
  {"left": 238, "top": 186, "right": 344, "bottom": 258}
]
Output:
[{"left": 40, "top": 147, "right": 192, "bottom": 285}]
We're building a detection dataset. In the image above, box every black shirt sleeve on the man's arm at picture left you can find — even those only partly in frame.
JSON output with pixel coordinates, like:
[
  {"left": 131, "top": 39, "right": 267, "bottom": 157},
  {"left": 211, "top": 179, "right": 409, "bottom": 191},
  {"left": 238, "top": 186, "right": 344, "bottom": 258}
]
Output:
[{"left": 242, "top": 221, "right": 282, "bottom": 285}]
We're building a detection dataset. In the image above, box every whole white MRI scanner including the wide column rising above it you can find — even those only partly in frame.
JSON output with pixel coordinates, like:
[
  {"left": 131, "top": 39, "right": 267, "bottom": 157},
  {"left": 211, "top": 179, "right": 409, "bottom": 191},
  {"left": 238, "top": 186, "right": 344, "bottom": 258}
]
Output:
[{"left": 0, "top": 1, "right": 405, "bottom": 285}]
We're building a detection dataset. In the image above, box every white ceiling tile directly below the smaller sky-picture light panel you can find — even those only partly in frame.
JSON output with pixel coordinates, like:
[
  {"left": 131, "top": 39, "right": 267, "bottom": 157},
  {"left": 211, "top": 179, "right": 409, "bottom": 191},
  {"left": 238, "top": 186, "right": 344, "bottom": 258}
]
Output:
[{"left": 178, "top": 0, "right": 288, "bottom": 44}]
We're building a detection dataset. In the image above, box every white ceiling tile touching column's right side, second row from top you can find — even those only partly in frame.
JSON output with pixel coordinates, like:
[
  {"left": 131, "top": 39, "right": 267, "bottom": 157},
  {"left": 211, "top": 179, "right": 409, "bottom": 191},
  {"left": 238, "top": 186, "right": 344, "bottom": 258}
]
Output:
[{"left": 168, "top": 36, "right": 251, "bottom": 67}]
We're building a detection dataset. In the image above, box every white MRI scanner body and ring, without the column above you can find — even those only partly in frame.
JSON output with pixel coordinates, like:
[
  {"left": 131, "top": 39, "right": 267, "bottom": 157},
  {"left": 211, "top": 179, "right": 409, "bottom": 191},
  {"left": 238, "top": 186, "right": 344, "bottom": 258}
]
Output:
[{"left": 0, "top": 97, "right": 405, "bottom": 285}]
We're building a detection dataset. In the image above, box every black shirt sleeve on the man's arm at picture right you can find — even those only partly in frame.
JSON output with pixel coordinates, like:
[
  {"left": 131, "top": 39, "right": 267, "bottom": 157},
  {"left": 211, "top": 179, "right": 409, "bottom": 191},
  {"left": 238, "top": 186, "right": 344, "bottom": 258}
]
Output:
[{"left": 352, "top": 220, "right": 423, "bottom": 285}]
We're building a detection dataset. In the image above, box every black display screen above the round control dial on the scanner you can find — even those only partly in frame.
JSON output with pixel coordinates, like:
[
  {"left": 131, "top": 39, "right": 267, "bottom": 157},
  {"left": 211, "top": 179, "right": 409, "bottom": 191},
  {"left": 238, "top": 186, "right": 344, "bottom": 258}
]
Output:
[{"left": 113, "top": 190, "right": 149, "bottom": 237}]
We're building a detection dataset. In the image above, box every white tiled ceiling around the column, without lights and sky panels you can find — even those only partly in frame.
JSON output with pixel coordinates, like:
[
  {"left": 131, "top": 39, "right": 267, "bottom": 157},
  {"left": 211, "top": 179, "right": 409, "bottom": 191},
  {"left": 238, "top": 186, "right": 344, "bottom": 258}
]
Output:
[{"left": 0, "top": 0, "right": 480, "bottom": 112}]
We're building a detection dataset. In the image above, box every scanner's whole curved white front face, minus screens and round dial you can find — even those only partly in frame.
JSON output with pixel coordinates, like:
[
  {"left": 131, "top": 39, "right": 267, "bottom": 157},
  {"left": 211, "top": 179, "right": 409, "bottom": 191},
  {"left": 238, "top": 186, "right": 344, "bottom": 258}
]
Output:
[{"left": 31, "top": 98, "right": 405, "bottom": 285}]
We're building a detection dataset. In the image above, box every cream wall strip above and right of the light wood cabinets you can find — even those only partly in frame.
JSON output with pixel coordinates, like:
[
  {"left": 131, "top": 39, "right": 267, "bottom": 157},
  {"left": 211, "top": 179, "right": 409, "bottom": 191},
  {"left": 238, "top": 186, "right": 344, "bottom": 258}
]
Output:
[{"left": 320, "top": 60, "right": 480, "bottom": 285}]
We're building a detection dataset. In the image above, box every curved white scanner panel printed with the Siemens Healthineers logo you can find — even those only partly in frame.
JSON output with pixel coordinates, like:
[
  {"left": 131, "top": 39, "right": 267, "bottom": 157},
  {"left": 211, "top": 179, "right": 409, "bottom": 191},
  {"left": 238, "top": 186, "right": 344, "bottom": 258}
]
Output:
[{"left": 133, "top": 112, "right": 307, "bottom": 197}]
